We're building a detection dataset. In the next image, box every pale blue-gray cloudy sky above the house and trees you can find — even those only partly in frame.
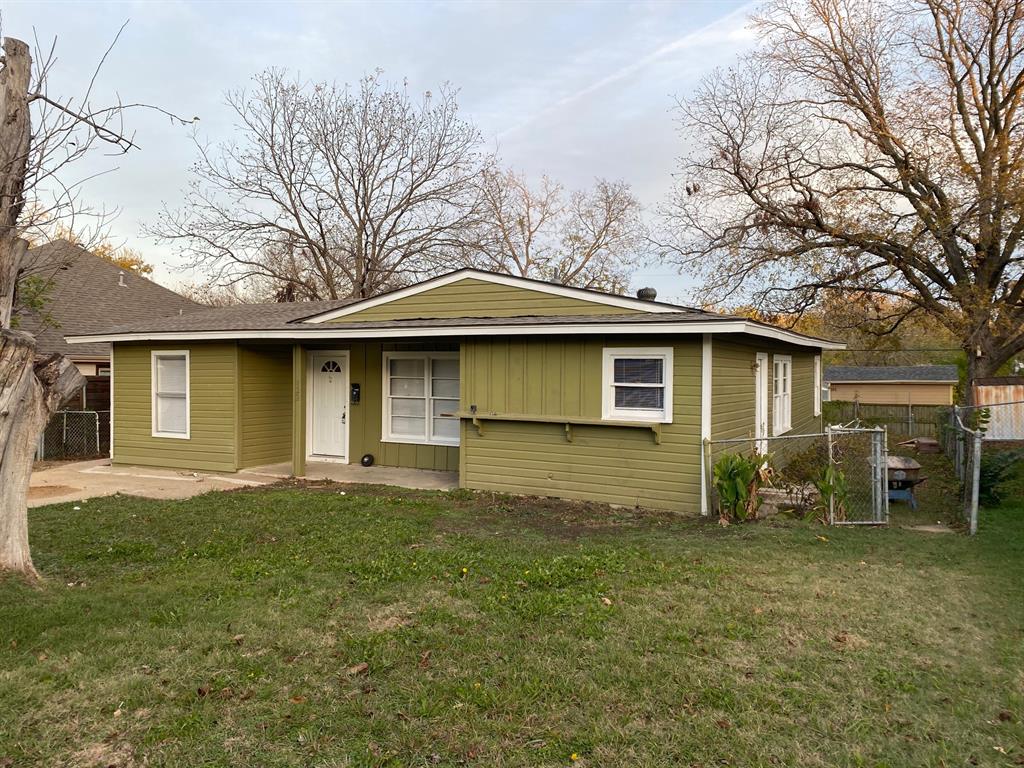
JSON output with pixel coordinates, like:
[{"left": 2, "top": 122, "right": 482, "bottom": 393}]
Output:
[{"left": 0, "top": 0, "right": 753, "bottom": 307}]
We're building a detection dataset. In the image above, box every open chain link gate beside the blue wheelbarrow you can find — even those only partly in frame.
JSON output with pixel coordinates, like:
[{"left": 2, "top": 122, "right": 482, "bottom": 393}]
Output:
[{"left": 825, "top": 425, "right": 889, "bottom": 525}]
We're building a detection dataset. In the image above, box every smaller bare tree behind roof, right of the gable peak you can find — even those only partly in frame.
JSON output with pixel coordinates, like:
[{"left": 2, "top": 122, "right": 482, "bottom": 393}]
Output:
[{"left": 468, "top": 171, "right": 645, "bottom": 293}]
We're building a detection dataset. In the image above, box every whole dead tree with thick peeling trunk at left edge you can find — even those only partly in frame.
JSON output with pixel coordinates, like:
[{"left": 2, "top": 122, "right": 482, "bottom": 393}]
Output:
[{"left": 0, "top": 33, "right": 190, "bottom": 577}]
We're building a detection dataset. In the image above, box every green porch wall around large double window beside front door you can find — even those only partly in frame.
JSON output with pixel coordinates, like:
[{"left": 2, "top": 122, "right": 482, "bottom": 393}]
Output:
[{"left": 306, "top": 340, "right": 459, "bottom": 472}]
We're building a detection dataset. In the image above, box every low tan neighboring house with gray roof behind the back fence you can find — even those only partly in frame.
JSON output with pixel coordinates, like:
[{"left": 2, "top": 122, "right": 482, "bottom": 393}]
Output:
[{"left": 825, "top": 366, "right": 959, "bottom": 406}]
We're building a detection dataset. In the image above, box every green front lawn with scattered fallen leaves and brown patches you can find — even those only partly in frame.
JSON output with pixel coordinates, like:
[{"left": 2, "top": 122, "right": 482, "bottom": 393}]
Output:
[{"left": 0, "top": 486, "right": 1024, "bottom": 767}]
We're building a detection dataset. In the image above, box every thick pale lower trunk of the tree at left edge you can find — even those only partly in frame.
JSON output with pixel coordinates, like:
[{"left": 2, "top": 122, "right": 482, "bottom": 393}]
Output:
[{"left": 0, "top": 329, "right": 85, "bottom": 577}]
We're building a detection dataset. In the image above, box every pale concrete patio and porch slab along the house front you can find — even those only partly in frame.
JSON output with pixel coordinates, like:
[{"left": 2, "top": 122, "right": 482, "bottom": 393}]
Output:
[{"left": 29, "top": 459, "right": 459, "bottom": 507}]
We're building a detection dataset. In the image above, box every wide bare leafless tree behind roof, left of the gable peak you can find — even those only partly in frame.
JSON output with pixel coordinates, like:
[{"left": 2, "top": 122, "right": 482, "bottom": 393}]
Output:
[{"left": 153, "top": 70, "right": 489, "bottom": 299}]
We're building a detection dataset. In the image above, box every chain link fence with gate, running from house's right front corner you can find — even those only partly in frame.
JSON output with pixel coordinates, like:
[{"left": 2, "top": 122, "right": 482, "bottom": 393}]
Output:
[{"left": 705, "top": 425, "right": 889, "bottom": 525}]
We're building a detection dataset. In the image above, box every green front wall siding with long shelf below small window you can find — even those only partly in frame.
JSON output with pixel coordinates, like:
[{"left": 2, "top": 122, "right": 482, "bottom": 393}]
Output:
[{"left": 461, "top": 338, "right": 700, "bottom": 513}]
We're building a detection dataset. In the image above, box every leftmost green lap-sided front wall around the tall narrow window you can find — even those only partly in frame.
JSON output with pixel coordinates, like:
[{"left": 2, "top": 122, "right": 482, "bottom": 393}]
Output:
[{"left": 113, "top": 342, "right": 238, "bottom": 472}]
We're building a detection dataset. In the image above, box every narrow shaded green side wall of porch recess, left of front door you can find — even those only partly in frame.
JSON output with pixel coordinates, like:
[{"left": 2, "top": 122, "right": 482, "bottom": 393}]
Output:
[{"left": 239, "top": 346, "right": 292, "bottom": 467}]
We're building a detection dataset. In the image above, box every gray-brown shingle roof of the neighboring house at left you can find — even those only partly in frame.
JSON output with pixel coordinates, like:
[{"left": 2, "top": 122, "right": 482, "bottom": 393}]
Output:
[{"left": 17, "top": 240, "right": 204, "bottom": 359}]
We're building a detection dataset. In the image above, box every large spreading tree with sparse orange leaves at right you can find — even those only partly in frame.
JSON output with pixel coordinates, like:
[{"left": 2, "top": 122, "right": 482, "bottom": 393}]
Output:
[{"left": 666, "top": 0, "right": 1024, "bottom": 387}]
